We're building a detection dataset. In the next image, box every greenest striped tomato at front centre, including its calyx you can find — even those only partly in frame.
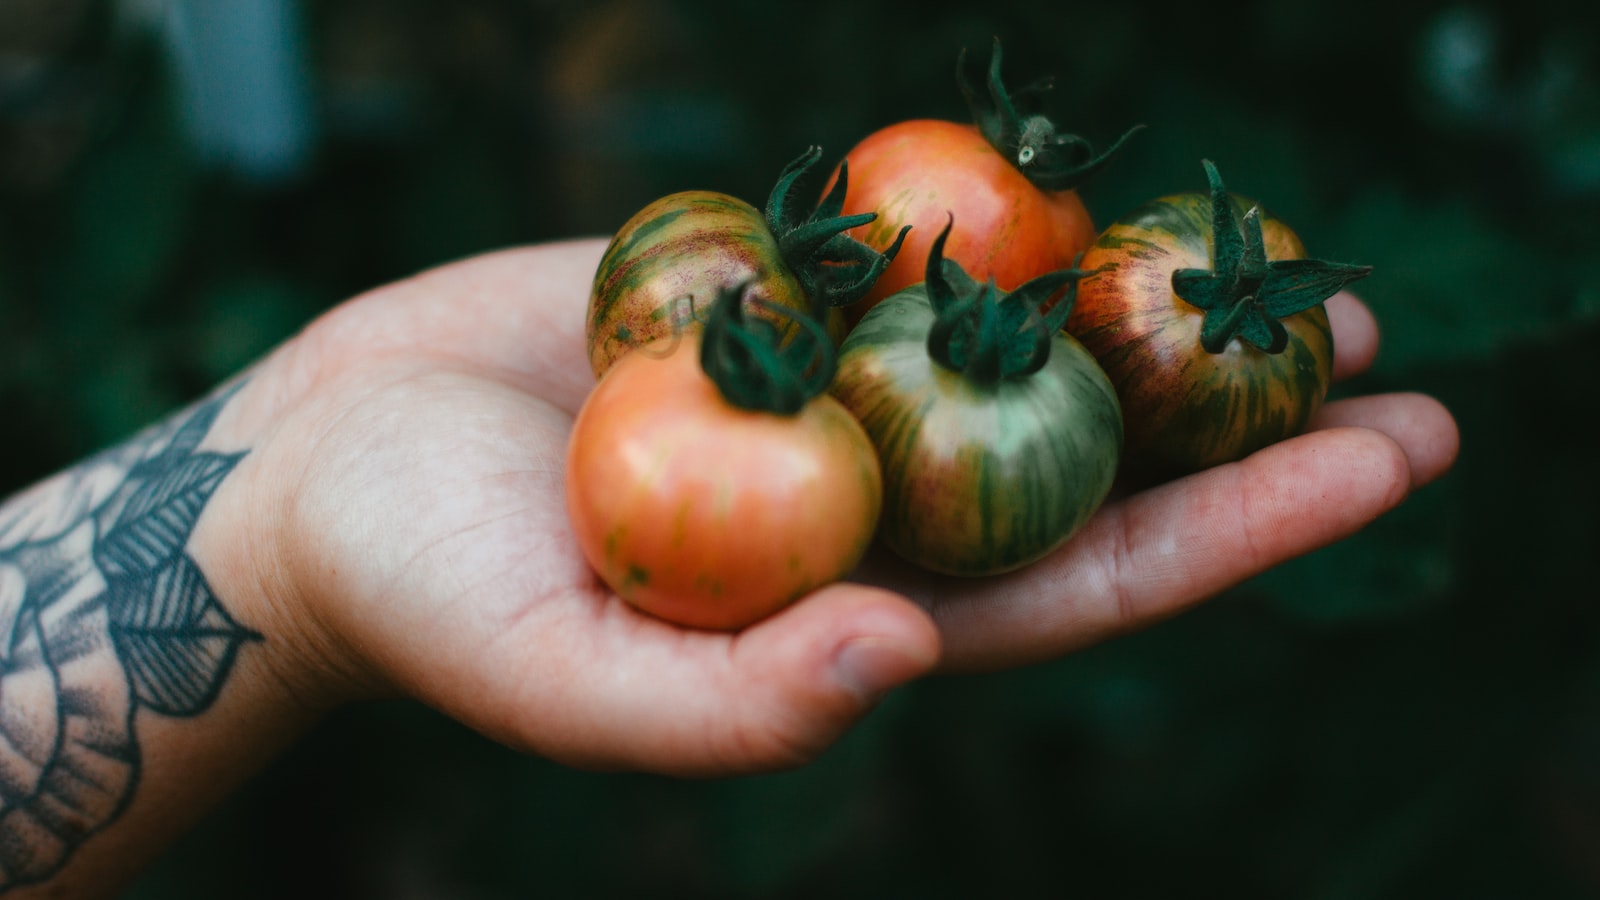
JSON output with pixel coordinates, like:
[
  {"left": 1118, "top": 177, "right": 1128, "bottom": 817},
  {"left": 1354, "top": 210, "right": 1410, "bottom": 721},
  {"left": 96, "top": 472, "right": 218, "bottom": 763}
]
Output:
[{"left": 832, "top": 219, "right": 1122, "bottom": 575}]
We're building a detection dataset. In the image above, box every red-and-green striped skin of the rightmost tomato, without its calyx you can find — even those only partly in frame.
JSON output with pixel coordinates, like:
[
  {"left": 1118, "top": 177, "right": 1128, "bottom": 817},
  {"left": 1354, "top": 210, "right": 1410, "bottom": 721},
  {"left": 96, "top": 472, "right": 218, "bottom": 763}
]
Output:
[{"left": 1067, "top": 194, "right": 1333, "bottom": 476}]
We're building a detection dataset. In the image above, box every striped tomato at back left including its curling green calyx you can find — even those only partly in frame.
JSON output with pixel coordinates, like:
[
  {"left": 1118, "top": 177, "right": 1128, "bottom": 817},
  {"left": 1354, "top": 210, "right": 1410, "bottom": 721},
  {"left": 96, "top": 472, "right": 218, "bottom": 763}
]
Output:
[{"left": 586, "top": 147, "right": 899, "bottom": 378}]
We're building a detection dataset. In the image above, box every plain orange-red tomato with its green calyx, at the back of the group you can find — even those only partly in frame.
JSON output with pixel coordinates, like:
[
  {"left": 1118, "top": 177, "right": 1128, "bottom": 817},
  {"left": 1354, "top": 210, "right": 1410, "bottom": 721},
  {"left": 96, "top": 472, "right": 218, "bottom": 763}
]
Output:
[{"left": 825, "top": 42, "right": 1133, "bottom": 320}]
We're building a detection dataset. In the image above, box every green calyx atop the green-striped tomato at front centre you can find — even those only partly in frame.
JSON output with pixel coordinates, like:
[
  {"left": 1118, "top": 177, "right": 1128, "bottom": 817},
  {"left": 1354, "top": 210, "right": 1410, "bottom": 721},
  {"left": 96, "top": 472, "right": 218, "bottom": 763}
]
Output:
[{"left": 923, "top": 216, "right": 1083, "bottom": 384}]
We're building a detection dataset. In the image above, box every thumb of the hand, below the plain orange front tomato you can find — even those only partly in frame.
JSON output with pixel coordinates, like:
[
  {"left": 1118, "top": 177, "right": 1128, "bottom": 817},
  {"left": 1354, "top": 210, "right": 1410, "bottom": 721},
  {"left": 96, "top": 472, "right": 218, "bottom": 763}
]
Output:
[{"left": 531, "top": 583, "right": 939, "bottom": 777}]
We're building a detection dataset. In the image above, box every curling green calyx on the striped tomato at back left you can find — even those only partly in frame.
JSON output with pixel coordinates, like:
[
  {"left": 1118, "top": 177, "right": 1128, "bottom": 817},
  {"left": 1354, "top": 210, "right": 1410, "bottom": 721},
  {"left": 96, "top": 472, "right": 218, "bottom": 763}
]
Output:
[{"left": 766, "top": 147, "right": 910, "bottom": 314}]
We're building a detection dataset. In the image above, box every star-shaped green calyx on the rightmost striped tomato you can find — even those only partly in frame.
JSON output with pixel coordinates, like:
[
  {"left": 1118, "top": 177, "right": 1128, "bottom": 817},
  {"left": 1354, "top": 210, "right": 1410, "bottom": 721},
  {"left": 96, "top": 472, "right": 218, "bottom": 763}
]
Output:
[{"left": 1173, "top": 160, "right": 1373, "bottom": 354}]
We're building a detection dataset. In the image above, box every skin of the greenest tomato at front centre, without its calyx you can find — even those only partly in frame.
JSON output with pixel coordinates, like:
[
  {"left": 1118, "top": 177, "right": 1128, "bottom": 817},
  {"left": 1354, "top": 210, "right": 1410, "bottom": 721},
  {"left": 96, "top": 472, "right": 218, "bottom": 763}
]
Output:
[{"left": 832, "top": 285, "right": 1122, "bottom": 575}]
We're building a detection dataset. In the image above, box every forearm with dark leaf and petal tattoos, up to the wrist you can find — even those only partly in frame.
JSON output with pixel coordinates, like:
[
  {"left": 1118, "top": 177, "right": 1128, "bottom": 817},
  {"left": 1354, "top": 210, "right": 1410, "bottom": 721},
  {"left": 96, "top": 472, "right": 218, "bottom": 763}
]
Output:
[{"left": 0, "top": 379, "right": 317, "bottom": 897}]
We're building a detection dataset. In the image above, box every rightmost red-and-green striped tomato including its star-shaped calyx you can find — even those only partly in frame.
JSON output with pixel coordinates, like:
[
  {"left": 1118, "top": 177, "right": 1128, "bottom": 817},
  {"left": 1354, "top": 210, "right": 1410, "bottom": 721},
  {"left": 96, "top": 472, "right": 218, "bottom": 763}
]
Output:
[{"left": 1067, "top": 162, "right": 1371, "bottom": 476}]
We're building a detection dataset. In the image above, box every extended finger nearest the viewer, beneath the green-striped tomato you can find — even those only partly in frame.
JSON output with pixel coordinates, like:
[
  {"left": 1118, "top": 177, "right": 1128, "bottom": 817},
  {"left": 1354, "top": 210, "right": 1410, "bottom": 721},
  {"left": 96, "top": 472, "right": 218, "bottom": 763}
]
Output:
[{"left": 890, "top": 428, "right": 1411, "bottom": 669}]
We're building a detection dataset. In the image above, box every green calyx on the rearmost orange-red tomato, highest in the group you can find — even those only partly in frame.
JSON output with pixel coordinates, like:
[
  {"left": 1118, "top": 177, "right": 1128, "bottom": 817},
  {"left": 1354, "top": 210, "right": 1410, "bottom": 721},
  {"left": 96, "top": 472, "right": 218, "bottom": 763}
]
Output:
[{"left": 955, "top": 38, "right": 1144, "bottom": 191}]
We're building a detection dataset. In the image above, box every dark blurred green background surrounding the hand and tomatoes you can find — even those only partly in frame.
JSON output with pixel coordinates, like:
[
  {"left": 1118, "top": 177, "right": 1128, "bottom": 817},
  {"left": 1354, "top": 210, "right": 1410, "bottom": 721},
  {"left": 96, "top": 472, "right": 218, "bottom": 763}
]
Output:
[{"left": 0, "top": 0, "right": 1600, "bottom": 900}]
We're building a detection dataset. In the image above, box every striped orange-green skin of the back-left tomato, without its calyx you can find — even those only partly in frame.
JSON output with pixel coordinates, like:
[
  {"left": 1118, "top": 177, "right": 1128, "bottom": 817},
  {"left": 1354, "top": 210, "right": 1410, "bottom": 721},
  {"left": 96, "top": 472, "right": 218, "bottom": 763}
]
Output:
[{"left": 586, "top": 191, "right": 845, "bottom": 378}]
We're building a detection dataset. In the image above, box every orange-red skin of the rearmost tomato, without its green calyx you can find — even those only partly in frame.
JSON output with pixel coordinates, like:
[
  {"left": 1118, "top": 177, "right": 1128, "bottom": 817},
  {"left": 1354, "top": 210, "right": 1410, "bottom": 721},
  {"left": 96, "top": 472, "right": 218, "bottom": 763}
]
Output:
[{"left": 835, "top": 119, "right": 1094, "bottom": 320}]
